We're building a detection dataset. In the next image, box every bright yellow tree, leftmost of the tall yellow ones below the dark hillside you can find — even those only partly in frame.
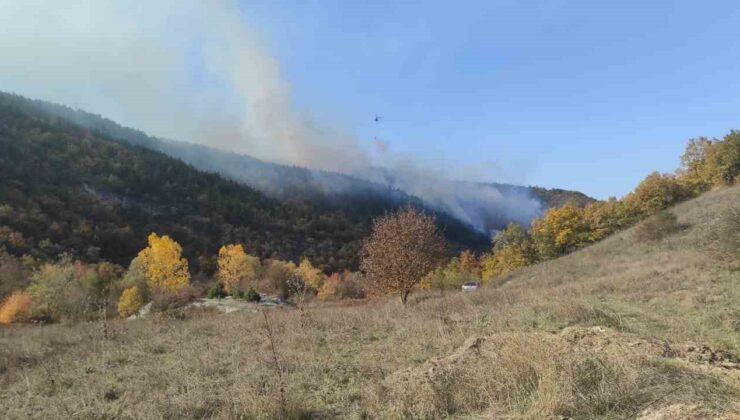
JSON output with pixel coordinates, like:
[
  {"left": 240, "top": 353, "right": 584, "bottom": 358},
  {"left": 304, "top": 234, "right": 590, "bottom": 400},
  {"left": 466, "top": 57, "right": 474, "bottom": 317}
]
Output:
[{"left": 138, "top": 233, "right": 190, "bottom": 292}]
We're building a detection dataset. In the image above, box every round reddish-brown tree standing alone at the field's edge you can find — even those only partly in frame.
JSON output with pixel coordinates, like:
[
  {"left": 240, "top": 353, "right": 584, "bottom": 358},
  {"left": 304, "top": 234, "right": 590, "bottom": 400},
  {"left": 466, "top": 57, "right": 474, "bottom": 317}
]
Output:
[{"left": 361, "top": 207, "right": 445, "bottom": 305}]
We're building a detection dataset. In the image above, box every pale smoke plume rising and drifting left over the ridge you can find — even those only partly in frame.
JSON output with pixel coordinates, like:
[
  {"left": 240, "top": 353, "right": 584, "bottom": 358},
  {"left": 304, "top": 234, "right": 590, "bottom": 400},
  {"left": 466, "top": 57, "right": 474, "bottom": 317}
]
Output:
[{"left": 0, "top": 0, "right": 540, "bottom": 229}]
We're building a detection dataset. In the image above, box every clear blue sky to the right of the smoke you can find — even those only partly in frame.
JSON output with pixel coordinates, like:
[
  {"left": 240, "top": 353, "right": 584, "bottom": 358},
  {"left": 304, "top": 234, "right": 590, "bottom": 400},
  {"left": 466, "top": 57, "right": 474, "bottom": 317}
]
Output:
[{"left": 236, "top": 0, "right": 740, "bottom": 198}]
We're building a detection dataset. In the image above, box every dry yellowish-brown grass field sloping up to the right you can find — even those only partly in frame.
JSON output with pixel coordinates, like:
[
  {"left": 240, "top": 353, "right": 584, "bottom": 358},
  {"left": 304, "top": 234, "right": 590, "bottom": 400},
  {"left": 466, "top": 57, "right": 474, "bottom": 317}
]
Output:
[{"left": 0, "top": 187, "right": 740, "bottom": 419}]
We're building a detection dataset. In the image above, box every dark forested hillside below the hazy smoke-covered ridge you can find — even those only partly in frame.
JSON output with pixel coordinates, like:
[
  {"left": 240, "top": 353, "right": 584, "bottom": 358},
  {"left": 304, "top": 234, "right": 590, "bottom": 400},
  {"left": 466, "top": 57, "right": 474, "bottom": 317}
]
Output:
[{"left": 0, "top": 95, "right": 488, "bottom": 271}]
